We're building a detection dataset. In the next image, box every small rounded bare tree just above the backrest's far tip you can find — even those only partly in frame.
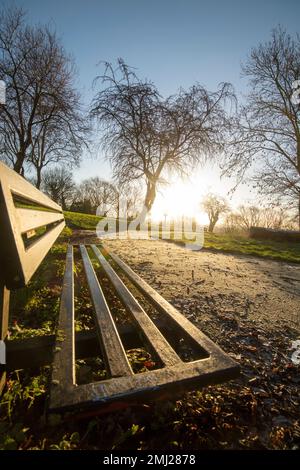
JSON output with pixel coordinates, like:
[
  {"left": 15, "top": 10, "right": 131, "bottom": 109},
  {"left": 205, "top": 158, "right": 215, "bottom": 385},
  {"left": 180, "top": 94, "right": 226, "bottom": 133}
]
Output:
[{"left": 42, "top": 167, "right": 75, "bottom": 210}]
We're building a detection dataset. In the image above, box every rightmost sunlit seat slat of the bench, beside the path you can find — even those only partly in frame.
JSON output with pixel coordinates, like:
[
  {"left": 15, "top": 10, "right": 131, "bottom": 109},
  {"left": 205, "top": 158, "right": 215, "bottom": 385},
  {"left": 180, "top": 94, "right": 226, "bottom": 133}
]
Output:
[{"left": 105, "top": 246, "right": 230, "bottom": 355}]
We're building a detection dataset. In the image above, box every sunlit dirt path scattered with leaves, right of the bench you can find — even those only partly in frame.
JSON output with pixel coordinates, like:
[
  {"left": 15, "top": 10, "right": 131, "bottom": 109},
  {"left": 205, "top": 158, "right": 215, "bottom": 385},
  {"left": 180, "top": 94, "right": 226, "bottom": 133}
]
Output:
[{"left": 102, "top": 240, "right": 300, "bottom": 332}]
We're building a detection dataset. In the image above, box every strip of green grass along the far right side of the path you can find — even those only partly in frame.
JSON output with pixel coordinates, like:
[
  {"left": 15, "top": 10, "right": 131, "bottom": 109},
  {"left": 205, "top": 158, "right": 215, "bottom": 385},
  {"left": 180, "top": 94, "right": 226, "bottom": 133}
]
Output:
[{"left": 190, "top": 233, "right": 300, "bottom": 263}]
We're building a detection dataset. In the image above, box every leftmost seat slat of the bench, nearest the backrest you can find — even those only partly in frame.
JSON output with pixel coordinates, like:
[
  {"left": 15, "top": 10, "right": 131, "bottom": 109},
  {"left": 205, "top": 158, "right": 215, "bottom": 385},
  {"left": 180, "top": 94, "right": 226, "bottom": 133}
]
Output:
[{"left": 52, "top": 245, "right": 76, "bottom": 393}]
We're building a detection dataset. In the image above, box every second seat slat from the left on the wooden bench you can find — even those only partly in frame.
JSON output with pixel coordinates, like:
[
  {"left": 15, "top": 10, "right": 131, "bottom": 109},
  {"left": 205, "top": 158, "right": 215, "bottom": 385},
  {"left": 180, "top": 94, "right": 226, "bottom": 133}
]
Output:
[{"left": 80, "top": 245, "right": 133, "bottom": 377}]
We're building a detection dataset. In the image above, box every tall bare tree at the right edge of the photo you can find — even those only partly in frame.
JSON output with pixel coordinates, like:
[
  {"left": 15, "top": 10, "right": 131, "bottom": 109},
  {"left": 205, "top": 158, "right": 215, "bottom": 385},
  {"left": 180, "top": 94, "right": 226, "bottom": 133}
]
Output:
[{"left": 225, "top": 27, "right": 300, "bottom": 227}]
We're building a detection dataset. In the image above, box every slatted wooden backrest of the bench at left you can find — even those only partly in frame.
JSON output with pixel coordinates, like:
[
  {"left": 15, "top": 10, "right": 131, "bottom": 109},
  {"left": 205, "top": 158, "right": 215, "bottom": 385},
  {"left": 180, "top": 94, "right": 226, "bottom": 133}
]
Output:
[{"left": 0, "top": 162, "right": 65, "bottom": 289}]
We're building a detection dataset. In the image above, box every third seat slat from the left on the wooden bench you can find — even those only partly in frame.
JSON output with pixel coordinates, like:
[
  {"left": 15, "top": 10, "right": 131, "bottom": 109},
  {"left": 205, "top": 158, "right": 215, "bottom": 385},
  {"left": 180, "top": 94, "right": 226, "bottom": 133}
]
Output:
[{"left": 92, "top": 245, "right": 181, "bottom": 366}]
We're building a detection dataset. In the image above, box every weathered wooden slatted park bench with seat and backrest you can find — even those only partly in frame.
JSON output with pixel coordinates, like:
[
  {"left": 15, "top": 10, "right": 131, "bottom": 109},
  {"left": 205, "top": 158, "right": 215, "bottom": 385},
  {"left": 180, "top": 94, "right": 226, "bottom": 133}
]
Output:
[{"left": 0, "top": 163, "right": 239, "bottom": 411}]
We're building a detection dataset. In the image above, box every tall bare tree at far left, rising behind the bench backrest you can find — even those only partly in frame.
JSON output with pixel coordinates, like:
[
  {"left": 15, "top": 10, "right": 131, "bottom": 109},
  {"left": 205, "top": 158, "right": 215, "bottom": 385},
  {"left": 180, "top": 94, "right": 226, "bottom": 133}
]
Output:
[{"left": 0, "top": 8, "right": 85, "bottom": 178}]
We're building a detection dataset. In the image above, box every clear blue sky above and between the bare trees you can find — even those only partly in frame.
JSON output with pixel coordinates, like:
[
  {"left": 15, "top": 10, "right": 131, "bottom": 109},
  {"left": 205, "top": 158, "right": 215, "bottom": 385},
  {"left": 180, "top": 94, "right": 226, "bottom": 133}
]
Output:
[{"left": 0, "top": 0, "right": 300, "bottom": 216}]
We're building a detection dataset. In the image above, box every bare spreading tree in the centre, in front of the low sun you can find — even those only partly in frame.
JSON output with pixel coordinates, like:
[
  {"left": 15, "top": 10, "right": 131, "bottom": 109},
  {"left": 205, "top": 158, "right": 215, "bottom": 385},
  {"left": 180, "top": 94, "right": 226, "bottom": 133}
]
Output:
[{"left": 90, "top": 59, "right": 234, "bottom": 218}]
